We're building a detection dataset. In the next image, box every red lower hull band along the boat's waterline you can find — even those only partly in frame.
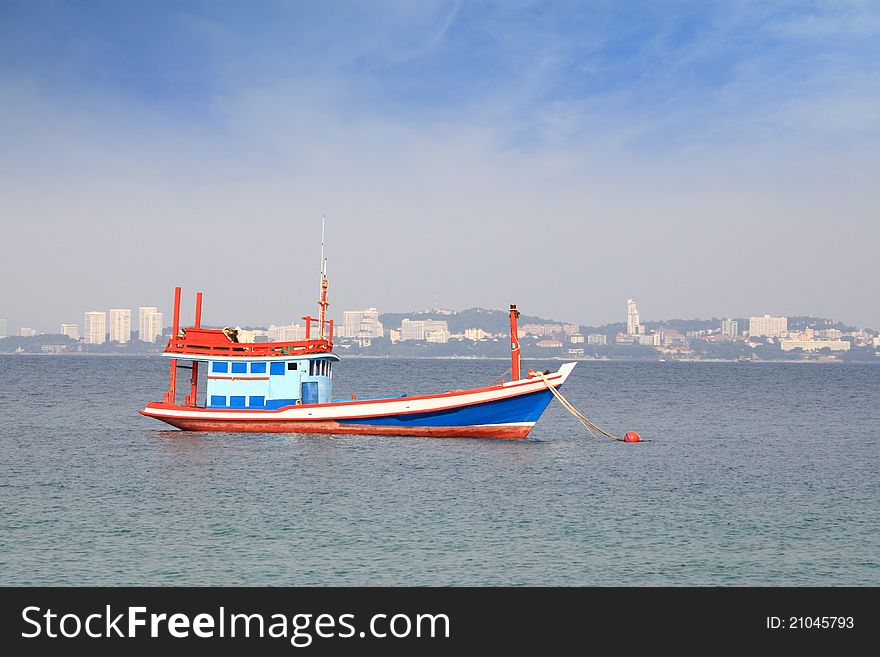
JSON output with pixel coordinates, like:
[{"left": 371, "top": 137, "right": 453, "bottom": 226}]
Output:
[{"left": 141, "top": 411, "right": 532, "bottom": 440}]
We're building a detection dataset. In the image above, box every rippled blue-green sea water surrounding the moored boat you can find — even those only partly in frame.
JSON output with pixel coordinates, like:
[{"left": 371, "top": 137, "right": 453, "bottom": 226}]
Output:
[{"left": 0, "top": 356, "right": 880, "bottom": 586}]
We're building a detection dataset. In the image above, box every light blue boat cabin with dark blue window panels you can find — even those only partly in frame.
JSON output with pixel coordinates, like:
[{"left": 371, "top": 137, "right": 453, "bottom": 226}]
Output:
[{"left": 205, "top": 357, "right": 335, "bottom": 410}]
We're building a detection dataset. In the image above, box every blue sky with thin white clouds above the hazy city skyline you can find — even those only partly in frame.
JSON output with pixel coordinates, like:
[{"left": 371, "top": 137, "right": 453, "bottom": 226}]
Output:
[{"left": 0, "top": 0, "right": 880, "bottom": 332}]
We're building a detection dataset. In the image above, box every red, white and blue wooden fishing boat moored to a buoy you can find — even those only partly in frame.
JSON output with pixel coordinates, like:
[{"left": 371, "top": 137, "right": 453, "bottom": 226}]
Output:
[{"left": 140, "top": 240, "right": 575, "bottom": 439}]
